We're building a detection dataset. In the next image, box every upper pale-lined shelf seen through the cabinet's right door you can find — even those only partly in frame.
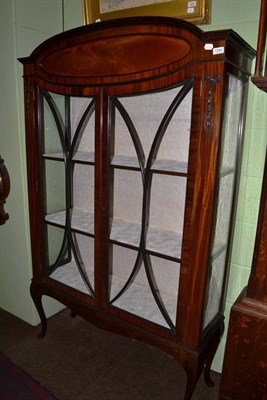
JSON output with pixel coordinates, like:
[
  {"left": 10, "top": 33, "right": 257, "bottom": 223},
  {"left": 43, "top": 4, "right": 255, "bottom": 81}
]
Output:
[{"left": 111, "top": 156, "right": 187, "bottom": 176}]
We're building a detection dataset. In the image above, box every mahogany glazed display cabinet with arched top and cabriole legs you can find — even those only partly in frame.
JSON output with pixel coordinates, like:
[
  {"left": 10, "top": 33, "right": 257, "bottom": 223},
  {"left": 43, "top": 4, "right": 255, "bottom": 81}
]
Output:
[{"left": 20, "top": 17, "right": 255, "bottom": 400}]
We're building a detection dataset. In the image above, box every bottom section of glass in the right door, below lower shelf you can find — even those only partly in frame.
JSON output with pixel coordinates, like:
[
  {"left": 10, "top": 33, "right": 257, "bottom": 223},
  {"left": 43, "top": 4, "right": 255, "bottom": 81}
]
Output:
[{"left": 110, "top": 245, "right": 180, "bottom": 328}]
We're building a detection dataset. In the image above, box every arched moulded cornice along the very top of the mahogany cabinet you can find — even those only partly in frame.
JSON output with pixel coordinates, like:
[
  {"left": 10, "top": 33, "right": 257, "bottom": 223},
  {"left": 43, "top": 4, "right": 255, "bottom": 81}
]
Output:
[{"left": 19, "top": 16, "right": 256, "bottom": 71}]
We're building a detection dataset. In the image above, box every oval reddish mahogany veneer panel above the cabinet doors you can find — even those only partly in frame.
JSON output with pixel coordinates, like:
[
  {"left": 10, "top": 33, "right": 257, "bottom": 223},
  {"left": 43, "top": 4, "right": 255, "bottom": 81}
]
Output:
[{"left": 40, "top": 34, "right": 190, "bottom": 78}]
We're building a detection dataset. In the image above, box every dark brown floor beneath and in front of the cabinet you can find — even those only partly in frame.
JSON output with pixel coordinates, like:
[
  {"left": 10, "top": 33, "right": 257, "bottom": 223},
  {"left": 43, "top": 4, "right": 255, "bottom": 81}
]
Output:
[{"left": 0, "top": 310, "right": 220, "bottom": 400}]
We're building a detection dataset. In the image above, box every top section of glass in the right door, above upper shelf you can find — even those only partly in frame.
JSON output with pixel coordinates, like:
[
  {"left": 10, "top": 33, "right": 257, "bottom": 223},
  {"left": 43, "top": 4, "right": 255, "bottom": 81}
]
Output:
[{"left": 114, "top": 83, "right": 192, "bottom": 166}]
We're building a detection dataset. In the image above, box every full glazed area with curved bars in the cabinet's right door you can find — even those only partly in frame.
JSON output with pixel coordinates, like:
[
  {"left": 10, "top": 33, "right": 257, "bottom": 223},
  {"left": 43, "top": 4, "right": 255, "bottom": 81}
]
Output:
[{"left": 109, "top": 79, "right": 193, "bottom": 330}]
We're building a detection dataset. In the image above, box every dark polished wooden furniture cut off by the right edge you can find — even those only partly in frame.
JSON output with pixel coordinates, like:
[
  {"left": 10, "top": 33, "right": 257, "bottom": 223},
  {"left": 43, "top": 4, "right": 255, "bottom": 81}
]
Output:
[{"left": 219, "top": 0, "right": 267, "bottom": 400}]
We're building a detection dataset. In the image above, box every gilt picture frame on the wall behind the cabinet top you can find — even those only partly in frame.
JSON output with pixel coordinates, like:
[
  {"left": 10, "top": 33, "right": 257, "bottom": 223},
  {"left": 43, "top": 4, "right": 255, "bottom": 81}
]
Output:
[{"left": 83, "top": 0, "right": 211, "bottom": 25}]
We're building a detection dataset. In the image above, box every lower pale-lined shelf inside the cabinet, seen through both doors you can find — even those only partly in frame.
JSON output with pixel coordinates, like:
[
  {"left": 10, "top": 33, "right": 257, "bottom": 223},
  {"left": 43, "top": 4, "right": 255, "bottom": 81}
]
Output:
[{"left": 45, "top": 209, "right": 182, "bottom": 262}]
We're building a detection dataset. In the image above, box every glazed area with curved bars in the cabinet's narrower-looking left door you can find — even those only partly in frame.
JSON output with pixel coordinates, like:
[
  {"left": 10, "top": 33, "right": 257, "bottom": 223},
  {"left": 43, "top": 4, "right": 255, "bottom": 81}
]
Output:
[{"left": 40, "top": 90, "right": 95, "bottom": 297}]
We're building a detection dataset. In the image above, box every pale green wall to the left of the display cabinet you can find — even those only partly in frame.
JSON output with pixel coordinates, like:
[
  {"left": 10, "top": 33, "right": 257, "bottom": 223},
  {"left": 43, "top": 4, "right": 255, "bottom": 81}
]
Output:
[{"left": 0, "top": 0, "right": 82, "bottom": 324}]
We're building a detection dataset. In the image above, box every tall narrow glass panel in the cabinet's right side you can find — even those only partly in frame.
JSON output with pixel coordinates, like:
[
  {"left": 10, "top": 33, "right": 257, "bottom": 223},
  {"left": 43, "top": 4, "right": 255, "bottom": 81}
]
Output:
[{"left": 204, "top": 75, "right": 244, "bottom": 328}]
